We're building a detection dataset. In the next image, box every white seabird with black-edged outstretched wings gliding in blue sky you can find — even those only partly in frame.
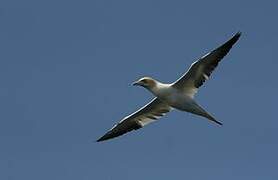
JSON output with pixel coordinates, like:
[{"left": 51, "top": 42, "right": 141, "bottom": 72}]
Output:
[{"left": 97, "top": 32, "right": 241, "bottom": 142}]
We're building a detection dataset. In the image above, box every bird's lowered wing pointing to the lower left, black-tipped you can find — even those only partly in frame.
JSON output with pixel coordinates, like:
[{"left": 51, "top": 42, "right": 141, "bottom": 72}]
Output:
[{"left": 97, "top": 98, "right": 171, "bottom": 142}]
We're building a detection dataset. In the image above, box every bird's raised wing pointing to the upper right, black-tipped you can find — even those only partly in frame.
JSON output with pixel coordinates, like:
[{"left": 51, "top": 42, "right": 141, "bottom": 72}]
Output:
[{"left": 173, "top": 32, "right": 241, "bottom": 97}]
